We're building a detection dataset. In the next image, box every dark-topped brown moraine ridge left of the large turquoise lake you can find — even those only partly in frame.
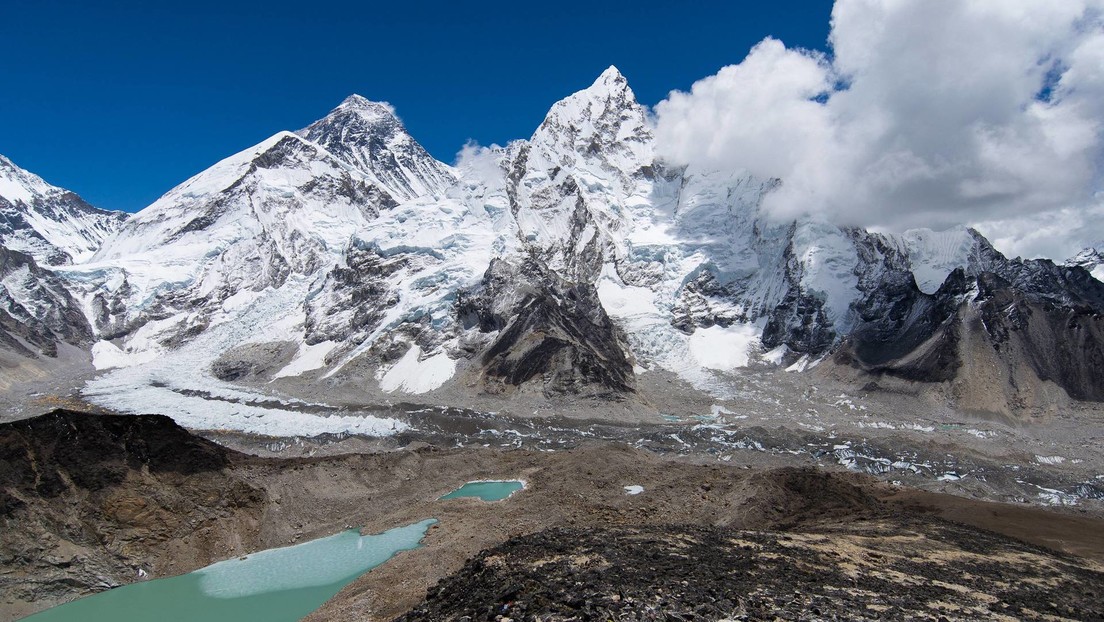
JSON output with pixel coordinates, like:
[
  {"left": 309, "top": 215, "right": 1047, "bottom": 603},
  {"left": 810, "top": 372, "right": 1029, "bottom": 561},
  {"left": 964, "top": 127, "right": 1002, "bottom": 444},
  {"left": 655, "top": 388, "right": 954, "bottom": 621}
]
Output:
[{"left": 0, "top": 410, "right": 265, "bottom": 620}]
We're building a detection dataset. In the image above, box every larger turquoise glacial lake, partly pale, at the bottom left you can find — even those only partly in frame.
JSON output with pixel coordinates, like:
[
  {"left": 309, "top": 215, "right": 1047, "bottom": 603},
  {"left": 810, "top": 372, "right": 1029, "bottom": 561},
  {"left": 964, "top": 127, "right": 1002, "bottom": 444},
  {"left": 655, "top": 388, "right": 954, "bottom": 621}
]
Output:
[{"left": 23, "top": 518, "right": 436, "bottom": 622}]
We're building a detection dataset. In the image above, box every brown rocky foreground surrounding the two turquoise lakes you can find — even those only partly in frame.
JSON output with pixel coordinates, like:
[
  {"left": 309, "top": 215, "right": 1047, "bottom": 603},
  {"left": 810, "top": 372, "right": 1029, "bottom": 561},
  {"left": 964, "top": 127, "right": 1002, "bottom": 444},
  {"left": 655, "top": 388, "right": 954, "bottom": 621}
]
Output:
[{"left": 0, "top": 411, "right": 1104, "bottom": 621}]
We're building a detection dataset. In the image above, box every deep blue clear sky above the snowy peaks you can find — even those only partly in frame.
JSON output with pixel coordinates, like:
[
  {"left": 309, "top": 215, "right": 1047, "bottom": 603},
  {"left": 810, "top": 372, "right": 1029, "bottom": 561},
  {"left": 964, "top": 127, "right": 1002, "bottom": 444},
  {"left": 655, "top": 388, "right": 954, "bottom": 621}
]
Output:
[{"left": 0, "top": 0, "right": 831, "bottom": 211}]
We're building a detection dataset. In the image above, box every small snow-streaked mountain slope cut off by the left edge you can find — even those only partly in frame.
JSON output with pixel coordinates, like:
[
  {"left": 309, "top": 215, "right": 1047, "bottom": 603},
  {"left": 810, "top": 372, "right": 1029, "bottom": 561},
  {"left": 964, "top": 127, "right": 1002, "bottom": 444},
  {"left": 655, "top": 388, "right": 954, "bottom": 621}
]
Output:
[{"left": 0, "top": 156, "right": 127, "bottom": 265}]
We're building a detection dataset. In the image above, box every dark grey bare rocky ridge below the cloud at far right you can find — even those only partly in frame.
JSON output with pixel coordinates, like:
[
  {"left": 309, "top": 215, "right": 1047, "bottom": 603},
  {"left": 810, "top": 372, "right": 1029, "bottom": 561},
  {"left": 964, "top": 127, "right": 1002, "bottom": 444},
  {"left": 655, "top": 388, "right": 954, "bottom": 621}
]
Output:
[{"left": 836, "top": 232, "right": 1104, "bottom": 410}]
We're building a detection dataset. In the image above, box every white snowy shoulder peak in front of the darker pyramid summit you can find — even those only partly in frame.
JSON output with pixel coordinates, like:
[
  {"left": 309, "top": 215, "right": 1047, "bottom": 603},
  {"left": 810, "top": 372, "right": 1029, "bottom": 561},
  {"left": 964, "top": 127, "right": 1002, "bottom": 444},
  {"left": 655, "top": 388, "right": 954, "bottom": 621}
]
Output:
[{"left": 81, "top": 133, "right": 395, "bottom": 334}]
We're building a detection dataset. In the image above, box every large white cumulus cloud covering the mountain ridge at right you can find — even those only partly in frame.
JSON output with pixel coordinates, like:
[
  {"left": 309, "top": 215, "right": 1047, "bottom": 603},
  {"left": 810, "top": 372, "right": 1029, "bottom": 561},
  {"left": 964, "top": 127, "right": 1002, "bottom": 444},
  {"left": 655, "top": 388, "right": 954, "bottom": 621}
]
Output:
[{"left": 655, "top": 0, "right": 1104, "bottom": 259}]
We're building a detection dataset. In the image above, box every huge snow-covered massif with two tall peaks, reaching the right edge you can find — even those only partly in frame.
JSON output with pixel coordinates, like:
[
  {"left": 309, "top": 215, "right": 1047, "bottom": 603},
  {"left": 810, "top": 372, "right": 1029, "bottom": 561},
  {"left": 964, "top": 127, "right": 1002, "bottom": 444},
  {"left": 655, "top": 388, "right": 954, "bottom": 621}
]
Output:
[{"left": 4, "top": 67, "right": 1104, "bottom": 428}]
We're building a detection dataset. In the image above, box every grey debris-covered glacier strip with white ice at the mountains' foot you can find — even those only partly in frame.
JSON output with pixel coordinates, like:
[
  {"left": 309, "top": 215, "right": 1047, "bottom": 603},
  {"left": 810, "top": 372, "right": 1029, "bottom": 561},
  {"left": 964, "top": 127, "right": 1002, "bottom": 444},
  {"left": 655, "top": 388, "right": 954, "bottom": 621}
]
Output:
[{"left": 0, "top": 357, "right": 1104, "bottom": 516}]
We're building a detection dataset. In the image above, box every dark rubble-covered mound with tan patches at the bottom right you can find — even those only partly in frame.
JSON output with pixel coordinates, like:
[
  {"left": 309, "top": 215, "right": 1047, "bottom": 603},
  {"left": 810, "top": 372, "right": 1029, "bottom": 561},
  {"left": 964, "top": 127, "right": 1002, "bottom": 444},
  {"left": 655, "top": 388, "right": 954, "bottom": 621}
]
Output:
[{"left": 395, "top": 517, "right": 1104, "bottom": 622}]
